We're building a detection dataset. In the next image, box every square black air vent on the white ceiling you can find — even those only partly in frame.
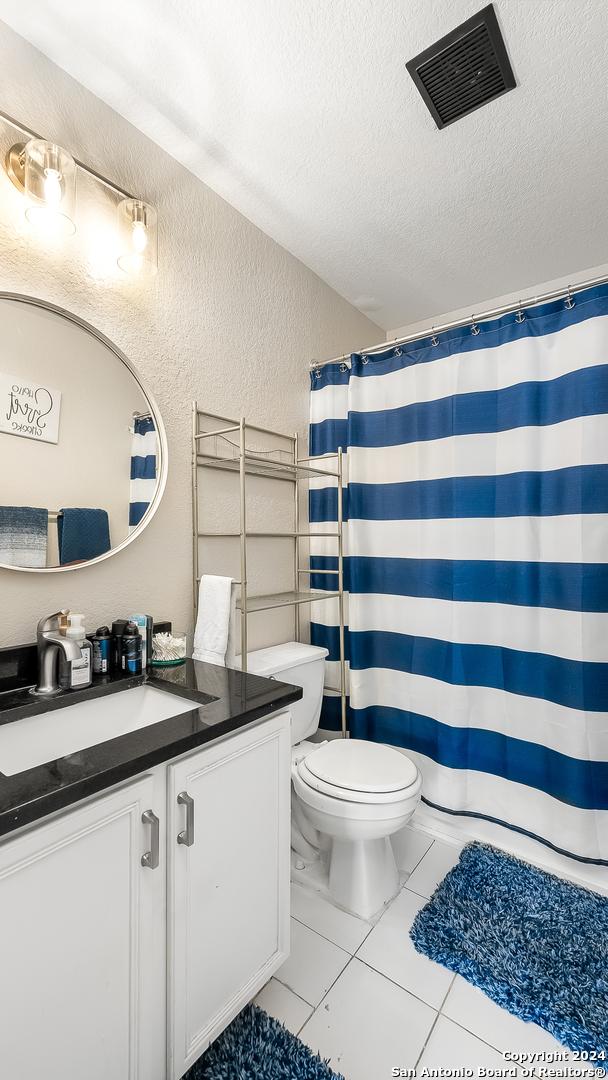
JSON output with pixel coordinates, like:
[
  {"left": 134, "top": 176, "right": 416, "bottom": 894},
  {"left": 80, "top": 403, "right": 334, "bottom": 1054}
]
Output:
[{"left": 407, "top": 3, "right": 516, "bottom": 127}]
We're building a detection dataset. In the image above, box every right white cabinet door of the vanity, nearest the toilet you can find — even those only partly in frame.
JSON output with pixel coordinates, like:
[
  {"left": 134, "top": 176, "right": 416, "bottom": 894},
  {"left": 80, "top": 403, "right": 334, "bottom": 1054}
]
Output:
[{"left": 167, "top": 713, "right": 291, "bottom": 1080}]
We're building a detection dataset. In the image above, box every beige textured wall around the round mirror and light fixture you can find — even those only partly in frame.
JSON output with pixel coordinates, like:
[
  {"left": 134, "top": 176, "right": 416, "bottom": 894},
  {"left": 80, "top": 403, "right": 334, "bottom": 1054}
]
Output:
[{"left": 0, "top": 24, "right": 382, "bottom": 645}]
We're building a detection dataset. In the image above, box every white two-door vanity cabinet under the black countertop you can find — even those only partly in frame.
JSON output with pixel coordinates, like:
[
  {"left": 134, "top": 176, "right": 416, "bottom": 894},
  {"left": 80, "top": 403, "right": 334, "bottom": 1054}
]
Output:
[{"left": 0, "top": 712, "right": 291, "bottom": 1080}]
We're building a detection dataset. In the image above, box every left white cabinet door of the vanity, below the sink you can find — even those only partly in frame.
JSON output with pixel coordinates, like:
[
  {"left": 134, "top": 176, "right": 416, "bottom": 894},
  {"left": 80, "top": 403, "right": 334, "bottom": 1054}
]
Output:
[{"left": 0, "top": 775, "right": 165, "bottom": 1080}]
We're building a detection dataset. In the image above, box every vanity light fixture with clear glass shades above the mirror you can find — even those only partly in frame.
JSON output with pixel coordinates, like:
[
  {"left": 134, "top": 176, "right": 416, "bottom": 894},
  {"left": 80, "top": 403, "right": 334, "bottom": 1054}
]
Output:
[{"left": 0, "top": 110, "right": 158, "bottom": 278}]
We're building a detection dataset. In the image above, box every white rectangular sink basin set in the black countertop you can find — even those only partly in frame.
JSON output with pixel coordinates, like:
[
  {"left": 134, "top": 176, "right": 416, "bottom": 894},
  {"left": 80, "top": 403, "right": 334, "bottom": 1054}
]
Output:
[{"left": 0, "top": 686, "right": 201, "bottom": 777}]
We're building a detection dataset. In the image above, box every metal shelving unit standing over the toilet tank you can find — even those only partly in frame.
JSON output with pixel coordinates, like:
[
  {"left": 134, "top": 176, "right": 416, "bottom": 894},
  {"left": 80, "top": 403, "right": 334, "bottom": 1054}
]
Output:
[{"left": 192, "top": 402, "right": 348, "bottom": 738}]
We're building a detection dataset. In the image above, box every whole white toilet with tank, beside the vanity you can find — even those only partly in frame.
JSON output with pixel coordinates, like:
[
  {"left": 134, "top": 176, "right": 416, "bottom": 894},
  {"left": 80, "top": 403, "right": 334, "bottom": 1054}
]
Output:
[{"left": 247, "top": 642, "right": 421, "bottom": 918}]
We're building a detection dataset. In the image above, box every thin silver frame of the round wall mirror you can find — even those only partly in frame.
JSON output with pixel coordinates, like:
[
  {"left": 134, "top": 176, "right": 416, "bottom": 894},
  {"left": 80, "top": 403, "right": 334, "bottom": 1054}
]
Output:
[{"left": 0, "top": 291, "right": 168, "bottom": 573}]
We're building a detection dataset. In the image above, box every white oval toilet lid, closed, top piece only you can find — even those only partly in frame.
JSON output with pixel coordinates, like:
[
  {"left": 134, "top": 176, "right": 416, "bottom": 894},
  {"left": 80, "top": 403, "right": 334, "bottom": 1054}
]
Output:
[{"left": 305, "top": 739, "right": 418, "bottom": 794}]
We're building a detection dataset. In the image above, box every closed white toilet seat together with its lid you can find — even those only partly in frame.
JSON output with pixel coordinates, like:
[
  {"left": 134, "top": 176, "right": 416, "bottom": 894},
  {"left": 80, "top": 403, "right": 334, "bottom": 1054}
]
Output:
[{"left": 295, "top": 739, "right": 420, "bottom": 806}]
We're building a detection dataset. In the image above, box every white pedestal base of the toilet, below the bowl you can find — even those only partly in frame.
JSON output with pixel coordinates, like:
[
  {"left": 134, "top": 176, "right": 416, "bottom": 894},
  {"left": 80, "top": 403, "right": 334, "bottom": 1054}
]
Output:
[{"left": 329, "top": 837, "right": 400, "bottom": 919}]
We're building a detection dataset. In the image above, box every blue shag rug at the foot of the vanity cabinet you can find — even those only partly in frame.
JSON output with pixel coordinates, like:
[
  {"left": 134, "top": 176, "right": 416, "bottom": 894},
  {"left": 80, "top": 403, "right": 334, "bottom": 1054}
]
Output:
[{"left": 183, "top": 1005, "right": 344, "bottom": 1080}]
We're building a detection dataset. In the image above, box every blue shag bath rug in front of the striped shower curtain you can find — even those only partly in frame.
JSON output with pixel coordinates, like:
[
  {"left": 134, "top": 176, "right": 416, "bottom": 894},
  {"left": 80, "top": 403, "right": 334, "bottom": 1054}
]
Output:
[{"left": 410, "top": 843, "right": 608, "bottom": 1054}]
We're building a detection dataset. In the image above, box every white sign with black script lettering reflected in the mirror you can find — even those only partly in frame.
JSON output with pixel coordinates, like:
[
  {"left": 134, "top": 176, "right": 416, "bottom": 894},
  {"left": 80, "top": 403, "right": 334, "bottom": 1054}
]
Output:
[{"left": 0, "top": 372, "right": 62, "bottom": 443}]
